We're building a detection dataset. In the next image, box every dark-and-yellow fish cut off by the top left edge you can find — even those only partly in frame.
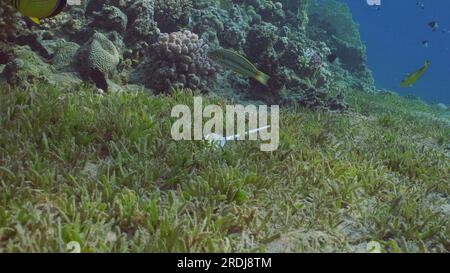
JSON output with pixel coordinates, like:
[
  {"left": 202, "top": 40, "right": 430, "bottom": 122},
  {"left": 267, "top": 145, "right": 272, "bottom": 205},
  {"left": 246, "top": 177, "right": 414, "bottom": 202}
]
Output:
[{"left": 11, "top": 0, "right": 67, "bottom": 24}]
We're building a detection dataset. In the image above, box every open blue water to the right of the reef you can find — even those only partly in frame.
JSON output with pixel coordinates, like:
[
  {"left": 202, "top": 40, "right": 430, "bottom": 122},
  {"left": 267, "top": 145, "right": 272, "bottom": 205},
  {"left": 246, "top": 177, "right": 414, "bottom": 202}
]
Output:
[{"left": 341, "top": 0, "right": 450, "bottom": 105}]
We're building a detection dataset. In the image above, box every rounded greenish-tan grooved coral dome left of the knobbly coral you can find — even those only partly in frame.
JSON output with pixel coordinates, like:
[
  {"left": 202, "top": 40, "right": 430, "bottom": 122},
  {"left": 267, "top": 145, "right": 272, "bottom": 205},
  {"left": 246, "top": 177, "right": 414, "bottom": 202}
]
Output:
[{"left": 75, "top": 32, "right": 121, "bottom": 90}]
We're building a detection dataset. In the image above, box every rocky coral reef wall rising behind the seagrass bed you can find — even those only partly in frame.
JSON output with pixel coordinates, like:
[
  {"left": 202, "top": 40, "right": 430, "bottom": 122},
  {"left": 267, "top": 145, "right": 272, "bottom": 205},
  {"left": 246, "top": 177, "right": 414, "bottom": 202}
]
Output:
[{"left": 0, "top": 0, "right": 373, "bottom": 105}]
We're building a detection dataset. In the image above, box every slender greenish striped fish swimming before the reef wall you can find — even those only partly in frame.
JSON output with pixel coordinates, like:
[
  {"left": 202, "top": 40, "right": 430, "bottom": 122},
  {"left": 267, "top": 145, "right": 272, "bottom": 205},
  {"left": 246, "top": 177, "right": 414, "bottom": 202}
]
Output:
[{"left": 208, "top": 49, "right": 270, "bottom": 85}]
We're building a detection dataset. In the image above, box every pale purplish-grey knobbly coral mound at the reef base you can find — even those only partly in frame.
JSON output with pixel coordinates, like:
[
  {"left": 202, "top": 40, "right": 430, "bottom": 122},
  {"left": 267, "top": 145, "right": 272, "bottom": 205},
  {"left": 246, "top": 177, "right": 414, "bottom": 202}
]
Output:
[{"left": 131, "top": 30, "right": 216, "bottom": 92}]
